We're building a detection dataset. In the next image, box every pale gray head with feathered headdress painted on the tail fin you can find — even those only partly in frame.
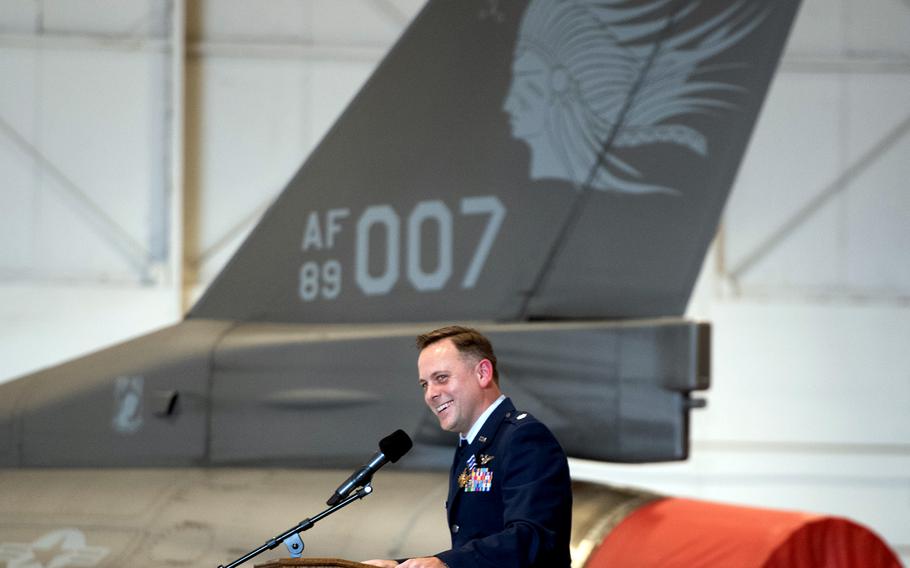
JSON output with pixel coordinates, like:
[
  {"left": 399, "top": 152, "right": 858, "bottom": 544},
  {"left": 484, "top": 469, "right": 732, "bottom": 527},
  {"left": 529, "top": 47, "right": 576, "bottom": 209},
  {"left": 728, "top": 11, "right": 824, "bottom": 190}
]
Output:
[{"left": 503, "top": 0, "right": 767, "bottom": 194}]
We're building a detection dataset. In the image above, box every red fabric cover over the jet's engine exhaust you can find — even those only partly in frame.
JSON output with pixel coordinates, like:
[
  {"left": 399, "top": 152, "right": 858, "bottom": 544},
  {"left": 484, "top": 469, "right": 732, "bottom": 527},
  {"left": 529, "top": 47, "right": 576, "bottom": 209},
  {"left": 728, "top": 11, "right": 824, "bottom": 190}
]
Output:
[{"left": 585, "top": 498, "right": 901, "bottom": 568}]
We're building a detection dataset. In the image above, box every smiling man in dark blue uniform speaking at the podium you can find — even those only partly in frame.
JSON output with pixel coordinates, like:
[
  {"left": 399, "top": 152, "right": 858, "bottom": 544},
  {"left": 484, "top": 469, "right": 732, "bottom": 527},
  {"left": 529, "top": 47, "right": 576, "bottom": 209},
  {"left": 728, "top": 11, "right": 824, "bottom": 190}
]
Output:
[{"left": 367, "top": 326, "right": 572, "bottom": 568}]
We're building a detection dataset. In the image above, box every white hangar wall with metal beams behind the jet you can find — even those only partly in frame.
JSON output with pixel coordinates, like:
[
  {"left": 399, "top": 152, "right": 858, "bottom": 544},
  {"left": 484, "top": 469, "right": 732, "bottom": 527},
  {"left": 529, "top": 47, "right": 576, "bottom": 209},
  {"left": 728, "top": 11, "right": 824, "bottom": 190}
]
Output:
[{"left": 0, "top": 0, "right": 910, "bottom": 563}]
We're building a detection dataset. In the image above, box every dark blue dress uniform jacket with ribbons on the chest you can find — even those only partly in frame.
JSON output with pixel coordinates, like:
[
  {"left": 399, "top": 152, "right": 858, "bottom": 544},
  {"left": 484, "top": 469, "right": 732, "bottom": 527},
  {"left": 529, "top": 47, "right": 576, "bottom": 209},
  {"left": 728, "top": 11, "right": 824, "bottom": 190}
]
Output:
[{"left": 436, "top": 398, "right": 572, "bottom": 568}]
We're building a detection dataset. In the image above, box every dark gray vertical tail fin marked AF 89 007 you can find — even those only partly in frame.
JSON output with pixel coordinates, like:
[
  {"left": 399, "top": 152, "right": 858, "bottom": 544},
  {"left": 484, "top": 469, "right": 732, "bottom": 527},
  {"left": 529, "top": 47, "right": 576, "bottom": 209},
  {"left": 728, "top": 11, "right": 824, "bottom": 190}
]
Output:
[{"left": 190, "top": 0, "right": 798, "bottom": 323}]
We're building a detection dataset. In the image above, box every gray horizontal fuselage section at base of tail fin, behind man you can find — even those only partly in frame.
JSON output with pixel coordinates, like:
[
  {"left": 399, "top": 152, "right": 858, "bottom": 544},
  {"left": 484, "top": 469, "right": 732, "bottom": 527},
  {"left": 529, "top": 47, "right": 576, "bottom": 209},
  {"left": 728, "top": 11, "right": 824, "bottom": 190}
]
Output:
[{"left": 0, "top": 319, "right": 710, "bottom": 467}]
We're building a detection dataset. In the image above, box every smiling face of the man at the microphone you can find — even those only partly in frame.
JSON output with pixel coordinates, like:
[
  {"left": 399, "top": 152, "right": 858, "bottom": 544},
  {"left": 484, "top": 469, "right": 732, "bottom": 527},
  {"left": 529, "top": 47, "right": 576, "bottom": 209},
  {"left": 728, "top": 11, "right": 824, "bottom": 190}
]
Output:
[{"left": 417, "top": 339, "right": 486, "bottom": 434}]
